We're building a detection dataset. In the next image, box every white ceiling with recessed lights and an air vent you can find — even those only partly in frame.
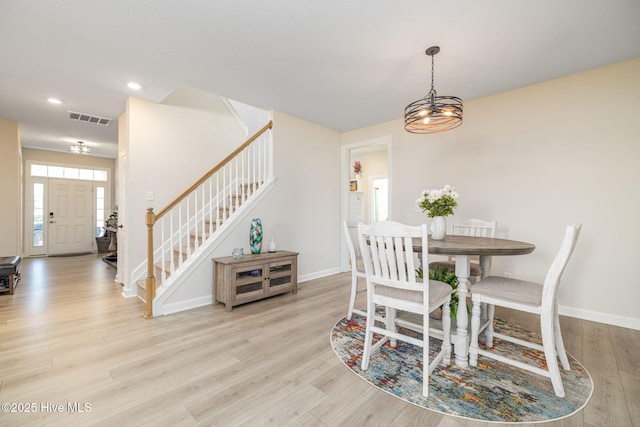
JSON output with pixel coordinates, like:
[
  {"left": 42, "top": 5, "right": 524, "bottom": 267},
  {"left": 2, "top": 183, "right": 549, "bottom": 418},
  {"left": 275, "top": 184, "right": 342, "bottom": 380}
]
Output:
[{"left": 0, "top": 0, "right": 640, "bottom": 157}]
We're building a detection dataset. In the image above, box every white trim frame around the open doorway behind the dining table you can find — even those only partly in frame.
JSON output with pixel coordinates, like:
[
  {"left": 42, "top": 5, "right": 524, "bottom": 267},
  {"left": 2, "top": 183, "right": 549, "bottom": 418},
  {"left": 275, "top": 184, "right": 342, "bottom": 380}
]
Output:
[{"left": 339, "top": 135, "right": 393, "bottom": 272}]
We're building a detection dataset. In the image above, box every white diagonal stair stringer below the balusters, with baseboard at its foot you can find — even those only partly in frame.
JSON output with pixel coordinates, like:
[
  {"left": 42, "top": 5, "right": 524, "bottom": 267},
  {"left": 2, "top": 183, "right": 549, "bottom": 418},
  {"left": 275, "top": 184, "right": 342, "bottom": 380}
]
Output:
[{"left": 152, "top": 178, "right": 276, "bottom": 317}]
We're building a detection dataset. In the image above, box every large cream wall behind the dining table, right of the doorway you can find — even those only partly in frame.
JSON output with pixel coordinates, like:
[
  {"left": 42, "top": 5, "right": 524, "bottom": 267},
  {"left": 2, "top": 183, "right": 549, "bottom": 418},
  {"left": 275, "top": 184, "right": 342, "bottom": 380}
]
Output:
[{"left": 342, "top": 58, "right": 640, "bottom": 329}]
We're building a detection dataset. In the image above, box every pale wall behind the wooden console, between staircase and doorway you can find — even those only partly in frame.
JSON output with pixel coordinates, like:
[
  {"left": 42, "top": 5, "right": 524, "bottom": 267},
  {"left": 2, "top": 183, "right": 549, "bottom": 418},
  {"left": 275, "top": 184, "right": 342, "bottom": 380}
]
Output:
[{"left": 209, "top": 111, "right": 340, "bottom": 280}]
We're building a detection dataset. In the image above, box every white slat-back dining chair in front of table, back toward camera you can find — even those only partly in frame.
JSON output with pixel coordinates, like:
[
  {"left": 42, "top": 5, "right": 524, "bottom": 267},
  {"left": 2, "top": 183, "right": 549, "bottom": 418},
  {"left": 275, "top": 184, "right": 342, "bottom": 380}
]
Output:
[{"left": 358, "top": 221, "right": 452, "bottom": 397}]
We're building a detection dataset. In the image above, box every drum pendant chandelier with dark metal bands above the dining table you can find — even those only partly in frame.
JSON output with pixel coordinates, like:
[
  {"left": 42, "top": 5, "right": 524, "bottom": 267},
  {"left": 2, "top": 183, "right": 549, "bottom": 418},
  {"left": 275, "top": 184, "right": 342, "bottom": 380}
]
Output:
[{"left": 404, "top": 46, "right": 462, "bottom": 134}]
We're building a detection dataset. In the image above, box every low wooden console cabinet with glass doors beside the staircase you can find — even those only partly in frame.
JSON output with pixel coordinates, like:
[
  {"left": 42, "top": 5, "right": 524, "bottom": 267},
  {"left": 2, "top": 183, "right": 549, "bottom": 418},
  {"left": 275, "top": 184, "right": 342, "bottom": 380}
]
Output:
[{"left": 213, "top": 251, "right": 298, "bottom": 312}]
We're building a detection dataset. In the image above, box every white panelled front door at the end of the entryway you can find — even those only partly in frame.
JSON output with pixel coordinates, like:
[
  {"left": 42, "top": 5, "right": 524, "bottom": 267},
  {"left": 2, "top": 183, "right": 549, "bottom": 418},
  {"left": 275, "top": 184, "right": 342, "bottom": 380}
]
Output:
[{"left": 47, "top": 179, "right": 95, "bottom": 255}]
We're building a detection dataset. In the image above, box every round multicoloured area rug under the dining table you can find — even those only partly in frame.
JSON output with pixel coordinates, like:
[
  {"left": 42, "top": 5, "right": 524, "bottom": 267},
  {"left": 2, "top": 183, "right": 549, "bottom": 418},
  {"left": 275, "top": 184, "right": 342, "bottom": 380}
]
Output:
[{"left": 331, "top": 314, "right": 593, "bottom": 423}]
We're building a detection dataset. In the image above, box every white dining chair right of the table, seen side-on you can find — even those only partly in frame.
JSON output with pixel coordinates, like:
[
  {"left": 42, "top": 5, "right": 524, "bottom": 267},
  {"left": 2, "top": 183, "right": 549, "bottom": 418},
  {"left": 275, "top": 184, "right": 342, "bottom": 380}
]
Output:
[{"left": 469, "top": 225, "right": 582, "bottom": 397}]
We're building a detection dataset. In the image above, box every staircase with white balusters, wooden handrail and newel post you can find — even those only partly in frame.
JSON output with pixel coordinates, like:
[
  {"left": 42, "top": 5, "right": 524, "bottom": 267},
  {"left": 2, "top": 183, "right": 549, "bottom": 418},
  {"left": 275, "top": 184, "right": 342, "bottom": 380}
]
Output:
[{"left": 132, "top": 122, "right": 274, "bottom": 318}]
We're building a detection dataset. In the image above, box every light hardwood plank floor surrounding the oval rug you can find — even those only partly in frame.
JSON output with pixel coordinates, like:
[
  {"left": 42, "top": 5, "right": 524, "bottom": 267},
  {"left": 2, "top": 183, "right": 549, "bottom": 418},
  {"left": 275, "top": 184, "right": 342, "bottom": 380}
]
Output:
[{"left": 0, "top": 255, "right": 640, "bottom": 427}]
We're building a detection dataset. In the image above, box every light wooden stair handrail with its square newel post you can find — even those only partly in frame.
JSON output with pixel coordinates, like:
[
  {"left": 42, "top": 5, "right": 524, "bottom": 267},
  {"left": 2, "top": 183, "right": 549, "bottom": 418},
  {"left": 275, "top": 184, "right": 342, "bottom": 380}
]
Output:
[{"left": 142, "top": 120, "right": 273, "bottom": 319}]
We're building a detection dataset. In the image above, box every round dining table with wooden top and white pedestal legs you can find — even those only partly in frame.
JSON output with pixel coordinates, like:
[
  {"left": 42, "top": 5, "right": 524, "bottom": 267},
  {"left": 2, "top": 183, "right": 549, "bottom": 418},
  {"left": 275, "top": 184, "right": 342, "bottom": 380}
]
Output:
[{"left": 413, "top": 235, "right": 536, "bottom": 368}]
